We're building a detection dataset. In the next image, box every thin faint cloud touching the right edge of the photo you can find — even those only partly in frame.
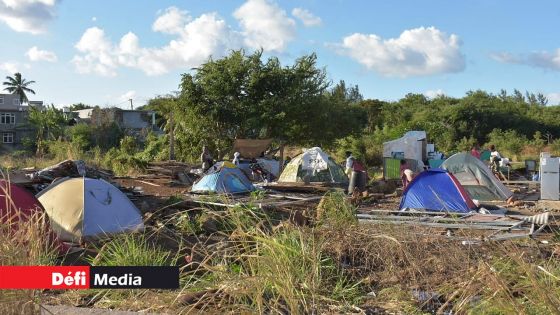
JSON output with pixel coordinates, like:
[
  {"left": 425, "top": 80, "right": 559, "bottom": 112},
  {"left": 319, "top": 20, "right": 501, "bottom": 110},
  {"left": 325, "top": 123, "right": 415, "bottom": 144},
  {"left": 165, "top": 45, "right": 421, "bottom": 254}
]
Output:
[{"left": 490, "top": 48, "right": 560, "bottom": 71}]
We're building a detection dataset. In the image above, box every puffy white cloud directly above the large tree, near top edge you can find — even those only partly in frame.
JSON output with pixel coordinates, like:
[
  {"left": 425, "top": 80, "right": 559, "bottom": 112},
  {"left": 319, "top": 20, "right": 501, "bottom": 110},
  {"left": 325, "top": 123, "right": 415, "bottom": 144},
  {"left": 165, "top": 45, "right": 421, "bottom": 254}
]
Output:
[{"left": 233, "top": 0, "right": 296, "bottom": 52}]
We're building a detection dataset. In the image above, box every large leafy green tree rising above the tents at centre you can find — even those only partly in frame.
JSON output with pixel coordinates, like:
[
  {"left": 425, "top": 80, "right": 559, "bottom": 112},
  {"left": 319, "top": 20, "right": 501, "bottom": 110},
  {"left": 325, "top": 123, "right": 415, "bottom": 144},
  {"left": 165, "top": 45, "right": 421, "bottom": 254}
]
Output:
[{"left": 175, "top": 50, "right": 366, "bottom": 162}]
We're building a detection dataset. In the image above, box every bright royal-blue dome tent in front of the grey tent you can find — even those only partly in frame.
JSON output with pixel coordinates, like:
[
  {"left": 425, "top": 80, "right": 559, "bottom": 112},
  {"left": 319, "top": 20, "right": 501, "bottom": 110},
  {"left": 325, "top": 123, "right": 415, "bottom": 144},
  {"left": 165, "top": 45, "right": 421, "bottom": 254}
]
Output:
[{"left": 400, "top": 168, "right": 476, "bottom": 213}]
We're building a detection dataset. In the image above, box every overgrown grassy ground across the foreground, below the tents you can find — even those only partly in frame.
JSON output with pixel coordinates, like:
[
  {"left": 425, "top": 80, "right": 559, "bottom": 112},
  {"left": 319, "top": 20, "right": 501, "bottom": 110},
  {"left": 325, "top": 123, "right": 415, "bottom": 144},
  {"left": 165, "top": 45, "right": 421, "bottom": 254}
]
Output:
[{"left": 0, "top": 193, "right": 560, "bottom": 314}]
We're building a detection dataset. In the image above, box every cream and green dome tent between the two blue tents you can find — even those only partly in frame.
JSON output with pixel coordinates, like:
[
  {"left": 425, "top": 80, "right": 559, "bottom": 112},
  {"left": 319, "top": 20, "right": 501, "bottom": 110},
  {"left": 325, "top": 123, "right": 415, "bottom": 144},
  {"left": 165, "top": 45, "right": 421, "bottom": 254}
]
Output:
[{"left": 278, "top": 148, "right": 348, "bottom": 184}]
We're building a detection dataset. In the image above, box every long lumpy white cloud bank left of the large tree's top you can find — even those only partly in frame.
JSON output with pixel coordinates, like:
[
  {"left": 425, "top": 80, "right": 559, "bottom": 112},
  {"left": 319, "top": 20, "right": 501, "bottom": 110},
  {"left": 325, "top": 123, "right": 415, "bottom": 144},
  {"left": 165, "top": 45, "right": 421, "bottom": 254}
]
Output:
[{"left": 72, "top": 7, "right": 240, "bottom": 76}]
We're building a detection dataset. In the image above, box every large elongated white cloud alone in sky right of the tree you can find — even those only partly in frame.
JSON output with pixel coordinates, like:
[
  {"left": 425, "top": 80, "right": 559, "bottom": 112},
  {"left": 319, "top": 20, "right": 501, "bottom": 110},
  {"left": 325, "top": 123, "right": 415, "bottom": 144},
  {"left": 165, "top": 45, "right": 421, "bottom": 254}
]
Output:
[{"left": 337, "top": 27, "right": 465, "bottom": 78}]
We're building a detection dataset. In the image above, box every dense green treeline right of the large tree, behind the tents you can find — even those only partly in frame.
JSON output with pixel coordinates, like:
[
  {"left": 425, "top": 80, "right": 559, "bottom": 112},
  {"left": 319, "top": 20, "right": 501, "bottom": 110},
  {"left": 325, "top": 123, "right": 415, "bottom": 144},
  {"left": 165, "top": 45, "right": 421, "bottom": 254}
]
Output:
[{"left": 362, "top": 91, "right": 560, "bottom": 155}]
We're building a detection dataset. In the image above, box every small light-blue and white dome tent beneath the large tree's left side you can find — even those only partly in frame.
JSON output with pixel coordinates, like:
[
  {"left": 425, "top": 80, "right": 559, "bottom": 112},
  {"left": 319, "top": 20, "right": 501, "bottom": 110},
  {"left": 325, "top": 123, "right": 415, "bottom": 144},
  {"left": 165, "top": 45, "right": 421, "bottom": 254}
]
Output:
[{"left": 191, "top": 162, "right": 255, "bottom": 194}]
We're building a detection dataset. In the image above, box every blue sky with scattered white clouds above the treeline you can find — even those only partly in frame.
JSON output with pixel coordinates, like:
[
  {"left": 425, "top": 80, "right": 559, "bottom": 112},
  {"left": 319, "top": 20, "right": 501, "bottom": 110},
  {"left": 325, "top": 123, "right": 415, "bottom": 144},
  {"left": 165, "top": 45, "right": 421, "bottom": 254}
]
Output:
[{"left": 0, "top": 0, "right": 560, "bottom": 107}]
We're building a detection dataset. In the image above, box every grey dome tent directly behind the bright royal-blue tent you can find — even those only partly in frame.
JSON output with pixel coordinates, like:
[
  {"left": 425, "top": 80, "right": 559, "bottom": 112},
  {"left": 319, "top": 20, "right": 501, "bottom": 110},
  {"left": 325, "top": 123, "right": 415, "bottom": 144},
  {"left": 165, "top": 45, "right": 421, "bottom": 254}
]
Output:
[{"left": 441, "top": 152, "right": 513, "bottom": 201}]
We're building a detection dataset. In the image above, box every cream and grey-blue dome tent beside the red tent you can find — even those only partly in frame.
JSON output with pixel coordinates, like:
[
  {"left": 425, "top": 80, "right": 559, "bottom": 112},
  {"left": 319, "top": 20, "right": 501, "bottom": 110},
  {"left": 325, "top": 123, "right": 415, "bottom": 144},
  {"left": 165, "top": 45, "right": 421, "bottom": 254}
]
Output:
[{"left": 37, "top": 178, "right": 144, "bottom": 242}]
